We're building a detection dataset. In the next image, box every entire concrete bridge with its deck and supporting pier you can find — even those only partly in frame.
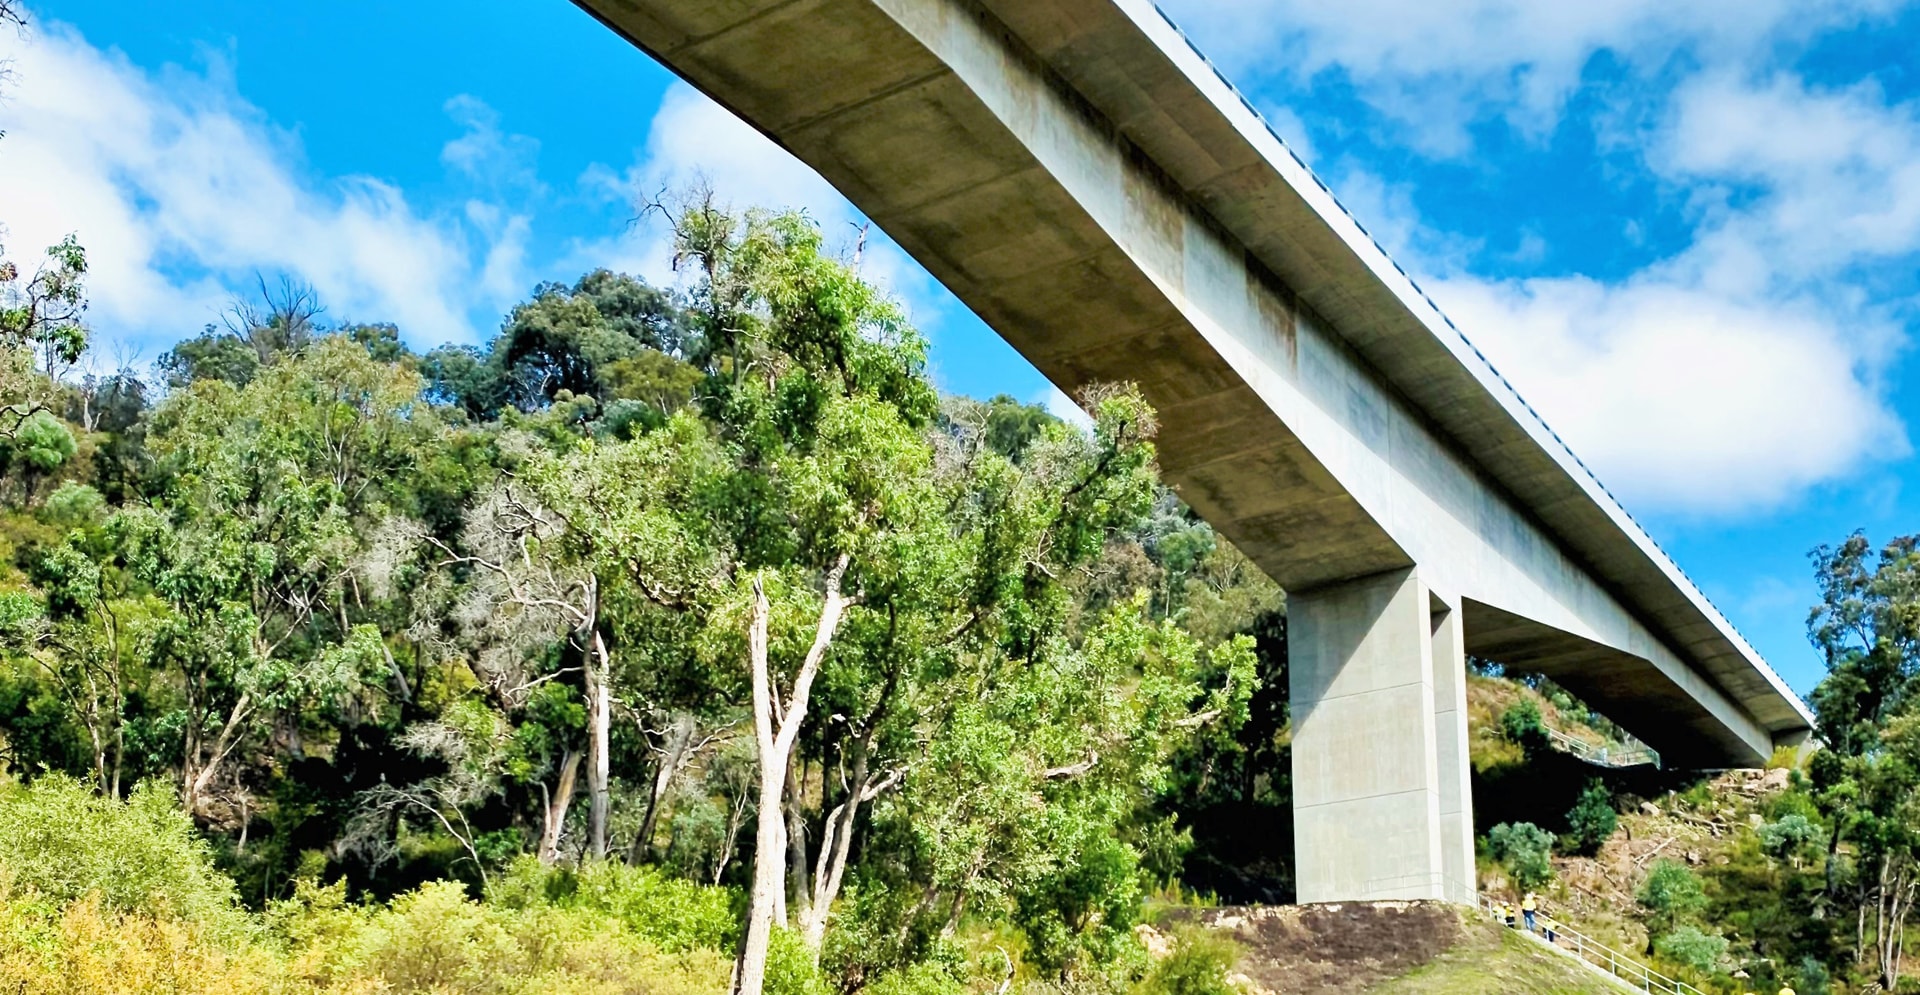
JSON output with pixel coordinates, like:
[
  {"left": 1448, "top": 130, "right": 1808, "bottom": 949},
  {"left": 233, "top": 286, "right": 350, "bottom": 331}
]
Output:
[{"left": 576, "top": 0, "right": 1812, "bottom": 914}]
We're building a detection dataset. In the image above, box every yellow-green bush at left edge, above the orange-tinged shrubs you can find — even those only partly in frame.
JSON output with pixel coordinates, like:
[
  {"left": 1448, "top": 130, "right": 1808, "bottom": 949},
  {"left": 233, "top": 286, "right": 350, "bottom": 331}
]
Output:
[{"left": 0, "top": 774, "right": 246, "bottom": 935}]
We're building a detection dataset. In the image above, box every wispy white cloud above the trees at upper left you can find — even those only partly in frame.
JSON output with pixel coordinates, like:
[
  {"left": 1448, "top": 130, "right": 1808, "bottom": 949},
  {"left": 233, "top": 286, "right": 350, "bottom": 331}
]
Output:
[{"left": 0, "top": 21, "right": 526, "bottom": 351}]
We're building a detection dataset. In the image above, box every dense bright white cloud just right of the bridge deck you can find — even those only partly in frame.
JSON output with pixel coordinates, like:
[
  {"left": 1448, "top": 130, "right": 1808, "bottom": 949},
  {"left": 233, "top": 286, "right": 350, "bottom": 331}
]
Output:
[{"left": 1432, "top": 267, "right": 1907, "bottom": 513}]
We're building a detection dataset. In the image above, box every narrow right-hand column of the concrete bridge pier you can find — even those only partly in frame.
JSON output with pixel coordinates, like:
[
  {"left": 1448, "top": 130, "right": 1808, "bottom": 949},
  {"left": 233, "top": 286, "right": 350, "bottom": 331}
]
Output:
[{"left": 1428, "top": 595, "right": 1478, "bottom": 905}]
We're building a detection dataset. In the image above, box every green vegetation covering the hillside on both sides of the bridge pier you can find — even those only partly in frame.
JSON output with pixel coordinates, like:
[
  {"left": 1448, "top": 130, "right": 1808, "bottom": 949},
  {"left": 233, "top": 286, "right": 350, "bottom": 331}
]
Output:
[{"left": 0, "top": 194, "right": 1920, "bottom": 995}]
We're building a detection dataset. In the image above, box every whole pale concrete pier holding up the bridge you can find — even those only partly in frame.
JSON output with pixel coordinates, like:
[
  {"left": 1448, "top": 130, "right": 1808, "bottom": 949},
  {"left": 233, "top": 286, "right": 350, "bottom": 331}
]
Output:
[{"left": 1286, "top": 569, "right": 1475, "bottom": 903}]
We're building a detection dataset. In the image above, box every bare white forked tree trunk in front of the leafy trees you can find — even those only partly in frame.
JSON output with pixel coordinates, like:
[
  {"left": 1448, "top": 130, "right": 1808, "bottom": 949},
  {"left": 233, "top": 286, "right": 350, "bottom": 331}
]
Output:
[{"left": 733, "top": 553, "right": 849, "bottom": 995}]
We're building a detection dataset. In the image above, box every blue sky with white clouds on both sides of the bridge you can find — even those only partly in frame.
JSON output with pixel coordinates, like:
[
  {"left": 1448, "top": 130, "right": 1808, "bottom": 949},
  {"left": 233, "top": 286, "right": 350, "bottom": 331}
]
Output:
[{"left": 0, "top": 0, "right": 1920, "bottom": 703}]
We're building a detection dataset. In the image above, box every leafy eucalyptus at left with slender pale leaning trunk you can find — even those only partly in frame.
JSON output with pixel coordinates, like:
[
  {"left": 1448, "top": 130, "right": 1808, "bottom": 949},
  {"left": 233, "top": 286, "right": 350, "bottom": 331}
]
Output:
[{"left": 129, "top": 336, "right": 436, "bottom": 818}]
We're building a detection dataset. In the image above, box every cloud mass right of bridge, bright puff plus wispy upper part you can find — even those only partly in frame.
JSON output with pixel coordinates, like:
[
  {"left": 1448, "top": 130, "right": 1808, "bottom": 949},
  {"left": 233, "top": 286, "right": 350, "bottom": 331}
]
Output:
[{"left": 1402, "top": 73, "right": 1920, "bottom": 513}]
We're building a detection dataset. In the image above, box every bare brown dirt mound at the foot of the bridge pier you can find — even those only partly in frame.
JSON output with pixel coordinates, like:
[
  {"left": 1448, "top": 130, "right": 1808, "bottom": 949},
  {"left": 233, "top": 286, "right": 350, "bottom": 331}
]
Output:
[{"left": 1164, "top": 901, "right": 1467, "bottom": 995}]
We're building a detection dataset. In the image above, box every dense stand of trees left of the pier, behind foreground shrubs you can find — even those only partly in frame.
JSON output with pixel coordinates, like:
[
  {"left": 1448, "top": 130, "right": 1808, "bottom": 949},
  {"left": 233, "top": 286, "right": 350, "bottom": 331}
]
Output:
[{"left": 0, "top": 200, "right": 1290, "bottom": 976}]
